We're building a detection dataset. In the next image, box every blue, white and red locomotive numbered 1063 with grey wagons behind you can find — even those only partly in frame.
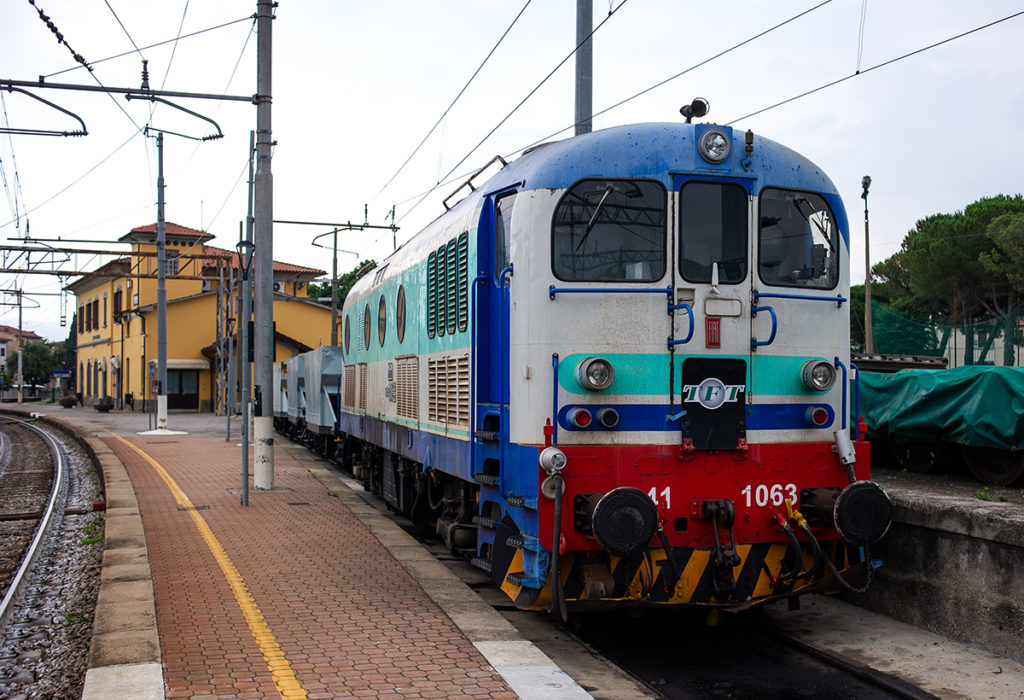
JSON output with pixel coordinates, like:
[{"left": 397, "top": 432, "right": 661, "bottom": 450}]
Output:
[{"left": 273, "top": 102, "right": 892, "bottom": 619}]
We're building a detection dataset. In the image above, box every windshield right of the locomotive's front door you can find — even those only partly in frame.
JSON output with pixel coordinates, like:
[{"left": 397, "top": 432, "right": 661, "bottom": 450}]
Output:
[{"left": 758, "top": 189, "right": 839, "bottom": 290}]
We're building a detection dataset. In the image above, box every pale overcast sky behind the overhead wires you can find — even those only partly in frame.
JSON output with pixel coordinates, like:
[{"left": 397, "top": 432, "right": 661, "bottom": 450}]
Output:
[{"left": 0, "top": 0, "right": 1024, "bottom": 340}]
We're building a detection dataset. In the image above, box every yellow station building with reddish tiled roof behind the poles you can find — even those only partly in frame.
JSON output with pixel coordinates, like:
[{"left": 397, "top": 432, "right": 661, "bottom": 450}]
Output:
[{"left": 68, "top": 223, "right": 331, "bottom": 411}]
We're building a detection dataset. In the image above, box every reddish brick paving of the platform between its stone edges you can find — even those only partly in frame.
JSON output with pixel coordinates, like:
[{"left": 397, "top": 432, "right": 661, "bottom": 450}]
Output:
[{"left": 103, "top": 436, "right": 516, "bottom": 698}]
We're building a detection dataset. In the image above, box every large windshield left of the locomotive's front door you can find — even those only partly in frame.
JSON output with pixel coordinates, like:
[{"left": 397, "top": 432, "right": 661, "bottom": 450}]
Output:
[{"left": 551, "top": 180, "right": 667, "bottom": 281}]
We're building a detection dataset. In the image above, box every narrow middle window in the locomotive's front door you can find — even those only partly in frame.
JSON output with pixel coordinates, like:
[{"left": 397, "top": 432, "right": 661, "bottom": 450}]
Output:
[{"left": 679, "top": 182, "right": 748, "bottom": 285}]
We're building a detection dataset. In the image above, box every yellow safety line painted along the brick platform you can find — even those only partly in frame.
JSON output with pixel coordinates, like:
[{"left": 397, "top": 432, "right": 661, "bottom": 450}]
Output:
[{"left": 104, "top": 431, "right": 306, "bottom": 699}]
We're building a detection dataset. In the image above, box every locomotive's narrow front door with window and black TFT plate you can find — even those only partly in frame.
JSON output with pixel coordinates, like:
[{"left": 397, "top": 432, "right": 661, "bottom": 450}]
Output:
[{"left": 670, "top": 176, "right": 752, "bottom": 449}]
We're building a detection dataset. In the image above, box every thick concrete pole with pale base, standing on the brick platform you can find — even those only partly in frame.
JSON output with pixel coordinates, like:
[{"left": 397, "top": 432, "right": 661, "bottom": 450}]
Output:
[{"left": 253, "top": 0, "right": 274, "bottom": 489}]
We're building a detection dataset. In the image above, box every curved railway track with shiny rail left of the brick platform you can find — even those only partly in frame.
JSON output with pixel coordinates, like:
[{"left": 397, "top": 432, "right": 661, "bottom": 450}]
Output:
[{"left": 0, "top": 417, "right": 68, "bottom": 630}]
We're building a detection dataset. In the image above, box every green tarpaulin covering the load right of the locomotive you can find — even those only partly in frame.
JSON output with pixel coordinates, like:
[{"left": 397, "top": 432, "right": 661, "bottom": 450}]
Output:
[{"left": 860, "top": 365, "right": 1024, "bottom": 449}]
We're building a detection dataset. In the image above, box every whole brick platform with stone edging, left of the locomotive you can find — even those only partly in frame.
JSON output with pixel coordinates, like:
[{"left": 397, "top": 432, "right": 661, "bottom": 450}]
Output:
[{"left": 9, "top": 404, "right": 590, "bottom": 699}]
